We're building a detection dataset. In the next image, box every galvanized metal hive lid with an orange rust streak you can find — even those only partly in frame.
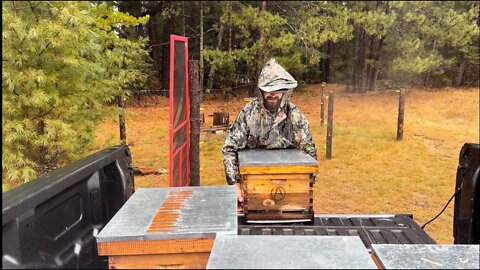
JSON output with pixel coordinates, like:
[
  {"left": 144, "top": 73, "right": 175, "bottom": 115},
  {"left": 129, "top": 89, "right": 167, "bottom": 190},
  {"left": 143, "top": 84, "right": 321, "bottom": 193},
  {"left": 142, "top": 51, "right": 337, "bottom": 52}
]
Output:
[{"left": 97, "top": 186, "right": 237, "bottom": 242}]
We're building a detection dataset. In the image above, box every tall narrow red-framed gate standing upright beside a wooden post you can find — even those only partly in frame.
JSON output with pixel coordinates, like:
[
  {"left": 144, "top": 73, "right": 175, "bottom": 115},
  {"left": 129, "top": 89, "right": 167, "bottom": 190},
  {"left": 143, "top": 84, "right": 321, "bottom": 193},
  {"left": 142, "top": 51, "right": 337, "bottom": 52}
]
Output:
[{"left": 169, "top": 35, "right": 190, "bottom": 187}]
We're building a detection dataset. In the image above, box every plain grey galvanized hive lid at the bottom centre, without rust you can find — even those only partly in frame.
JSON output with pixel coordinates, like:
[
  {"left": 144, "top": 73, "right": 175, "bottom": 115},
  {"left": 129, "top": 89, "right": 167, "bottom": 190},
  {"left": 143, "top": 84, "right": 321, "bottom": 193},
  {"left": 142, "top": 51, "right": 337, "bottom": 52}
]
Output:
[{"left": 207, "top": 234, "right": 376, "bottom": 269}]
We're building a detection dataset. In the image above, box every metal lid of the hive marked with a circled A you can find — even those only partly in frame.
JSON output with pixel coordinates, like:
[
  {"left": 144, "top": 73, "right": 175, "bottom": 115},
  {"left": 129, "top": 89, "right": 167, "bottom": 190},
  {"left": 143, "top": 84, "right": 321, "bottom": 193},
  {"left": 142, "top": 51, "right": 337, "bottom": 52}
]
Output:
[{"left": 238, "top": 148, "right": 318, "bottom": 167}]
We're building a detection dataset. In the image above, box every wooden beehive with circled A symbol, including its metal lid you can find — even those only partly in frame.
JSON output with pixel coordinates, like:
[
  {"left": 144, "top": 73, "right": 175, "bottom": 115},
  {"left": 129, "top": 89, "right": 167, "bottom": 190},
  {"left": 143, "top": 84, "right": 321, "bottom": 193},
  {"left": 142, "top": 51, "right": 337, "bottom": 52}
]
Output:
[{"left": 238, "top": 149, "right": 318, "bottom": 220}]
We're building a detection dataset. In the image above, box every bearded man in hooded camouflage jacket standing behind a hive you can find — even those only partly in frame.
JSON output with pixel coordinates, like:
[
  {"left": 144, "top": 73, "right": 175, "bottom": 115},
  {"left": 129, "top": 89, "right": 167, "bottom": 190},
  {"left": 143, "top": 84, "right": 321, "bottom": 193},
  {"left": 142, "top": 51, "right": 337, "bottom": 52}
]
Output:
[{"left": 222, "top": 59, "right": 317, "bottom": 205}]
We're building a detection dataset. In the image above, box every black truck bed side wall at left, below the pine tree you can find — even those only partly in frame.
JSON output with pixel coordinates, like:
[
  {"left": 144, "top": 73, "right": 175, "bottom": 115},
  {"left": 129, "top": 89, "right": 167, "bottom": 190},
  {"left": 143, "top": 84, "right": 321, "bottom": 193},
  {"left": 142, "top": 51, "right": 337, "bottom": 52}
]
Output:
[{"left": 2, "top": 146, "right": 134, "bottom": 269}]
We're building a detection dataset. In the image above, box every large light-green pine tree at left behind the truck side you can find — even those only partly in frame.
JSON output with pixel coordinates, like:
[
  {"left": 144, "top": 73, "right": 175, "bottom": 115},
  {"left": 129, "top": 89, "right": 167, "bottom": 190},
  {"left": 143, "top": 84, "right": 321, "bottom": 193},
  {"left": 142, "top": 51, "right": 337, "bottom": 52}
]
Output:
[{"left": 2, "top": 1, "right": 148, "bottom": 190}]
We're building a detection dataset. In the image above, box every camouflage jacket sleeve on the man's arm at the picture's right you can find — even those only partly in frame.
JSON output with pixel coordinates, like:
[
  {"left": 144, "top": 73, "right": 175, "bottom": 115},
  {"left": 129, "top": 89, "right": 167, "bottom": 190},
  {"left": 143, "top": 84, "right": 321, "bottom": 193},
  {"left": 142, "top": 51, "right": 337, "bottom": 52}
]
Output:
[{"left": 292, "top": 109, "right": 317, "bottom": 159}]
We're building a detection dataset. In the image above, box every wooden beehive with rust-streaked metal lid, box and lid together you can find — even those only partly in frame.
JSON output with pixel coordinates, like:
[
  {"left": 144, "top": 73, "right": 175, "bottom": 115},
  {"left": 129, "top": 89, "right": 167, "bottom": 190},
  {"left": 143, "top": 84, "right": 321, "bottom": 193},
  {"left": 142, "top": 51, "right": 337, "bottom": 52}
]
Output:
[{"left": 97, "top": 186, "right": 237, "bottom": 269}]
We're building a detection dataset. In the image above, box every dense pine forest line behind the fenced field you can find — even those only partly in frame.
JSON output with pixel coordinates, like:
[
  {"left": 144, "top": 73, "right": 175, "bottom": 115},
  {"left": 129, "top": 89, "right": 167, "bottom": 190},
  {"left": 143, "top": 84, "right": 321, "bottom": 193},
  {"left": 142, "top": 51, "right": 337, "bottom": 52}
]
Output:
[{"left": 117, "top": 1, "right": 480, "bottom": 95}]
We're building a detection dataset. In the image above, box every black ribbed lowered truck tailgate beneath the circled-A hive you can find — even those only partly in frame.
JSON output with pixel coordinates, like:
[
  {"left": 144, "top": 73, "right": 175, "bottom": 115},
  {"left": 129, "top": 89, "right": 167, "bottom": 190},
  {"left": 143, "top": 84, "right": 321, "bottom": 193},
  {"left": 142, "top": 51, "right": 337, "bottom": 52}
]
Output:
[{"left": 238, "top": 214, "right": 435, "bottom": 250}]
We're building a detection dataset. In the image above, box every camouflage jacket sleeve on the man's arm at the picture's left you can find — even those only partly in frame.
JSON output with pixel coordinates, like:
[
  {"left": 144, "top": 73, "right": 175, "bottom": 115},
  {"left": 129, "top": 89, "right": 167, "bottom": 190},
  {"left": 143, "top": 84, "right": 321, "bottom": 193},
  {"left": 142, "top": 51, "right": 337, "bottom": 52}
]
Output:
[{"left": 222, "top": 109, "right": 248, "bottom": 185}]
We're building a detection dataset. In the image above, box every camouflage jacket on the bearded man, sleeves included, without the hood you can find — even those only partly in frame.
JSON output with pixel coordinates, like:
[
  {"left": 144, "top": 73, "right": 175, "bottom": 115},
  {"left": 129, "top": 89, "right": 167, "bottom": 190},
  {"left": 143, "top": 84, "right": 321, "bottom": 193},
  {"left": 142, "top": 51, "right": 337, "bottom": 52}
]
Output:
[{"left": 222, "top": 89, "right": 317, "bottom": 185}]
